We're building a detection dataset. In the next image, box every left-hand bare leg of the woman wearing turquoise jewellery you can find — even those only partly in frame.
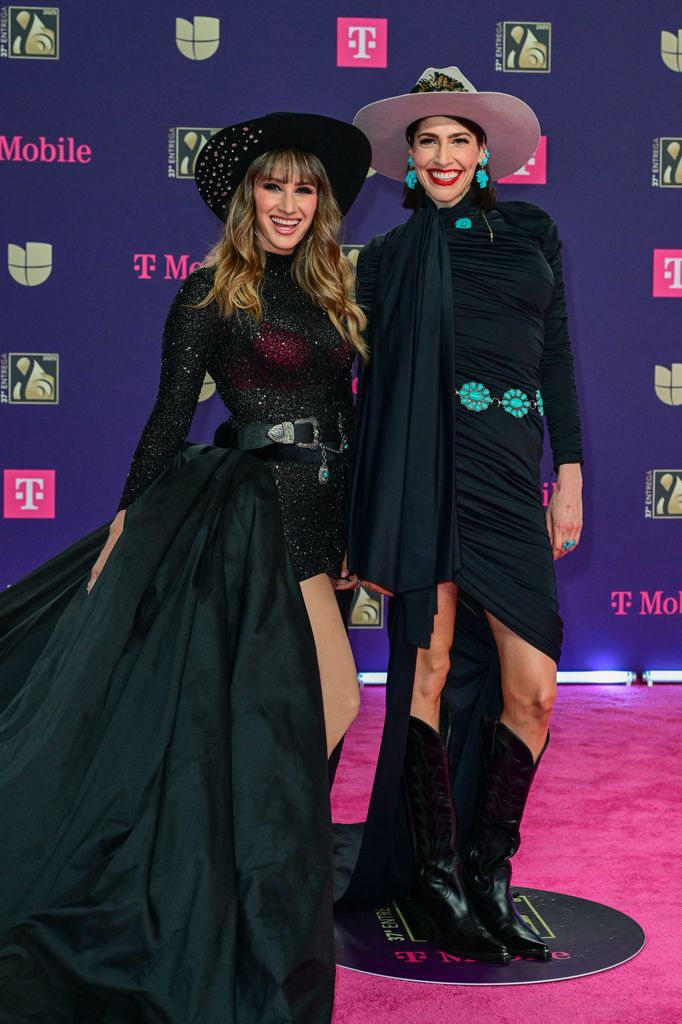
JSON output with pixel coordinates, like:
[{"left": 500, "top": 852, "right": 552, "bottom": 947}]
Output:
[{"left": 410, "top": 583, "right": 457, "bottom": 732}]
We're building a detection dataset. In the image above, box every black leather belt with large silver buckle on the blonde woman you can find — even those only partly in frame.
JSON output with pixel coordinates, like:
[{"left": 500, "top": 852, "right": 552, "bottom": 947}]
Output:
[{"left": 213, "top": 417, "right": 340, "bottom": 462}]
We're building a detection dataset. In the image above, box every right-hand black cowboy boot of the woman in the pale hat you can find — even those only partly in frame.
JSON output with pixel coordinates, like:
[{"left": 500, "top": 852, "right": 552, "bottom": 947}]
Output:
[{"left": 464, "top": 718, "right": 551, "bottom": 959}]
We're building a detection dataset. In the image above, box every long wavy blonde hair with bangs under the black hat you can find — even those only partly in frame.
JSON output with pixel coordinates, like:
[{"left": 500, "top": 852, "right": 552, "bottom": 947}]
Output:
[{"left": 199, "top": 150, "right": 368, "bottom": 359}]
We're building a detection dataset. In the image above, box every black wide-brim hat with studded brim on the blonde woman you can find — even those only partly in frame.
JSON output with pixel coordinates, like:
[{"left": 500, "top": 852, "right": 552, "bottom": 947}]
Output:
[{"left": 195, "top": 114, "right": 372, "bottom": 220}]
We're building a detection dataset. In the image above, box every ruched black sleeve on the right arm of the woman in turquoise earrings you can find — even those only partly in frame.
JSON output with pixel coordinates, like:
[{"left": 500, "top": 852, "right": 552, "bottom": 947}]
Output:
[{"left": 540, "top": 221, "right": 583, "bottom": 470}]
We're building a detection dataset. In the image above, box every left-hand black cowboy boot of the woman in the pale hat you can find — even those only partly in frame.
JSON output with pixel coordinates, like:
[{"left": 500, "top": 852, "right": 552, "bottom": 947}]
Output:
[{"left": 403, "top": 718, "right": 511, "bottom": 964}]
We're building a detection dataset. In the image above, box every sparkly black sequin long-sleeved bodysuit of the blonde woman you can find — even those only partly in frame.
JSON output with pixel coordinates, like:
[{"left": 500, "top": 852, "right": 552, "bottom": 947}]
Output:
[{"left": 120, "top": 254, "right": 353, "bottom": 580}]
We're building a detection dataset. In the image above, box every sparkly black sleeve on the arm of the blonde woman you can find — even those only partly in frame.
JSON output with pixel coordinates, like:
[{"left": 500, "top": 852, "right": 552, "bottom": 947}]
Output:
[{"left": 119, "top": 268, "right": 217, "bottom": 509}]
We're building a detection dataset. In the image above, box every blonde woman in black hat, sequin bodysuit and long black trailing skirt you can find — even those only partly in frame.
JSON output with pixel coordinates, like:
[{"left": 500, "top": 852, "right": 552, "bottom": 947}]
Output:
[{"left": 0, "top": 114, "right": 370, "bottom": 1024}]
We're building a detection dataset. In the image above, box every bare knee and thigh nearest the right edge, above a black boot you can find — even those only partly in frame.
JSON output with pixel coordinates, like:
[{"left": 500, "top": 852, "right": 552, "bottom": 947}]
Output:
[{"left": 485, "top": 611, "right": 556, "bottom": 761}]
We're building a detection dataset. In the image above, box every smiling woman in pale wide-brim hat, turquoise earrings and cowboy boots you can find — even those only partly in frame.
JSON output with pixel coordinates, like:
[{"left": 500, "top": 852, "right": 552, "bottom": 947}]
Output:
[{"left": 343, "top": 68, "right": 583, "bottom": 963}]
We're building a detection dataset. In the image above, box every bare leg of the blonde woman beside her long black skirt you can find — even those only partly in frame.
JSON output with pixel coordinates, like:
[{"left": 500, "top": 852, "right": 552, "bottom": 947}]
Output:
[{"left": 301, "top": 573, "right": 359, "bottom": 757}]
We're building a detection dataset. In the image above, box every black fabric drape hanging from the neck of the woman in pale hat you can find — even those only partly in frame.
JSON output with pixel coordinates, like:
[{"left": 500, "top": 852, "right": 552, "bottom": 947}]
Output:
[{"left": 348, "top": 199, "right": 460, "bottom": 646}]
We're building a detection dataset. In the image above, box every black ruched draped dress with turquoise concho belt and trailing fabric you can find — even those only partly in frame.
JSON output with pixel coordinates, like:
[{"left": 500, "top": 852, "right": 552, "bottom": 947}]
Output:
[{"left": 337, "top": 197, "right": 583, "bottom": 906}]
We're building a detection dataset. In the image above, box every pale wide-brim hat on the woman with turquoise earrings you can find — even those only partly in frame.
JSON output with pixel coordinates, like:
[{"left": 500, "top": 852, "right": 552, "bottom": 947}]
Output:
[{"left": 353, "top": 68, "right": 540, "bottom": 181}]
